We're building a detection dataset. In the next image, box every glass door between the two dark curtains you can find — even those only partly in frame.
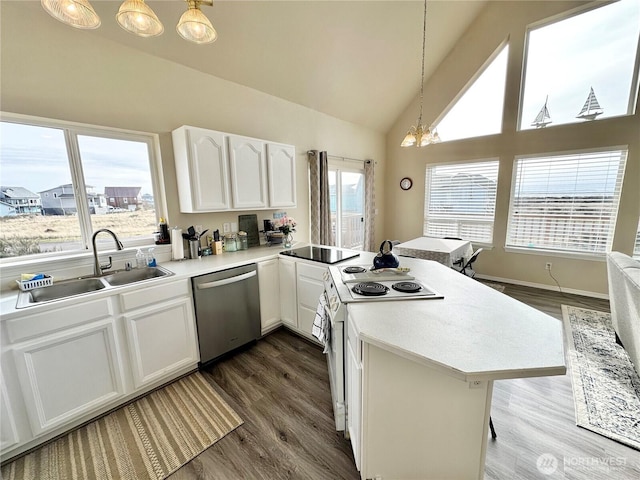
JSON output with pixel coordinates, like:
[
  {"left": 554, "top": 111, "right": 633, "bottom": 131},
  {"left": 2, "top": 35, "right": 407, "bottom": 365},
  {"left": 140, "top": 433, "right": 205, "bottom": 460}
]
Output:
[{"left": 329, "top": 161, "right": 364, "bottom": 250}]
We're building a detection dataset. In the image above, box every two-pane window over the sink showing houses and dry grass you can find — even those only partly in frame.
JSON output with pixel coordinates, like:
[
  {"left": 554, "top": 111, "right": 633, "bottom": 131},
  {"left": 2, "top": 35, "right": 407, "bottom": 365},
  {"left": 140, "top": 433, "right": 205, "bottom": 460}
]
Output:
[{"left": 0, "top": 115, "right": 164, "bottom": 257}]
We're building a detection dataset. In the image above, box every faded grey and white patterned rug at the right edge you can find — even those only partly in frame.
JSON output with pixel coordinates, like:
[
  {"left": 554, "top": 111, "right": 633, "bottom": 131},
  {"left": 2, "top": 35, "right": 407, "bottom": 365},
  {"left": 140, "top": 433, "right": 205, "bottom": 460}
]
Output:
[{"left": 562, "top": 305, "right": 640, "bottom": 450}]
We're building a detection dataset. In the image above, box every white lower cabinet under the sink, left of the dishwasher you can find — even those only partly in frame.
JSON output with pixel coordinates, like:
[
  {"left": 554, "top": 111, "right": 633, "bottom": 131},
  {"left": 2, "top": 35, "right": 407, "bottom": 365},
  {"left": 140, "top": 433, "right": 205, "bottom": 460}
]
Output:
[{"left": 0, "top": 279, "right": 199, "bottom": 461}]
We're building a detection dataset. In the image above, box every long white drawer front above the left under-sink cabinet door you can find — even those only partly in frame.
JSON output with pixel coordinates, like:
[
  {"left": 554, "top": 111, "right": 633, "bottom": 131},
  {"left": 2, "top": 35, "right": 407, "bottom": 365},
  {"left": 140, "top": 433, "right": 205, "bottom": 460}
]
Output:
[{"left": 7, "top": 298, "right": 113, "bottom": 343}]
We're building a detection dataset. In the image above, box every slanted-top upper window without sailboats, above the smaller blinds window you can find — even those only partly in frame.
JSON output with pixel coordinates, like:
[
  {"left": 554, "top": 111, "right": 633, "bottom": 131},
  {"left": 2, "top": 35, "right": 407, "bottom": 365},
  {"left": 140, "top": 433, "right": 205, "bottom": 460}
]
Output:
[{"left": 436, "top": 45, "right": 509, "bottom": 142}]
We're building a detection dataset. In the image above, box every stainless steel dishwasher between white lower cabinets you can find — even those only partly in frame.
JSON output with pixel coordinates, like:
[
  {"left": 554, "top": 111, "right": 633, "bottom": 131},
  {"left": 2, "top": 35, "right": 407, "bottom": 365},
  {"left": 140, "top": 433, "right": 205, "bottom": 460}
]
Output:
[{"left": 191, "top": 264, "right": 260, "bottom": 364}]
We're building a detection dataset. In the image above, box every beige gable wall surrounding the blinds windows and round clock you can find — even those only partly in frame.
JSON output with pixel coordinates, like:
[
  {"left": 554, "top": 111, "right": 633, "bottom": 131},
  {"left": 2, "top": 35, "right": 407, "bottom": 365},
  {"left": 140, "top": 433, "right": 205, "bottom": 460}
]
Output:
[{"left": 385, "top": 1, "right": 640, "bottom": 294}]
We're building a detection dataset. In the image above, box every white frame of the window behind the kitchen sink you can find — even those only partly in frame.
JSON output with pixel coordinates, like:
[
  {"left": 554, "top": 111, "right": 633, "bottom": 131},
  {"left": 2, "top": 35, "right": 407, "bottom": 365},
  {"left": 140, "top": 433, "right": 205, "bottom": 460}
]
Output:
[{"left": 0, "top": 111, "right": 167, "bottom": 266}]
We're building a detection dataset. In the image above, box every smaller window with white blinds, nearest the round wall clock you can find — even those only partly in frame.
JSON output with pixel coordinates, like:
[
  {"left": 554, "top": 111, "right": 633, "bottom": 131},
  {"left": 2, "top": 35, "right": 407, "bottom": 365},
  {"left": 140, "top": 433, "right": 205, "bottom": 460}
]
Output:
[{"left": 423, "top": 159, "right": 498, "bottom": 244}]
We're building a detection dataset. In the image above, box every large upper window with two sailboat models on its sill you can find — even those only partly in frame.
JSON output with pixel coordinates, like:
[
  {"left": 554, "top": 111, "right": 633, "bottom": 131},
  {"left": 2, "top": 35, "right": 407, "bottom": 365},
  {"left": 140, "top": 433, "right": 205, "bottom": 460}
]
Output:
[{"left": 520, "top": 0, "right": 640, "bottom": 130}]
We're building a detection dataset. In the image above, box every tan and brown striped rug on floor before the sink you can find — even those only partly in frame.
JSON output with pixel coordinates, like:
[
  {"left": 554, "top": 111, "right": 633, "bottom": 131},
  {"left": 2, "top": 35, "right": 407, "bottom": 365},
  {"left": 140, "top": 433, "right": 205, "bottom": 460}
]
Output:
[{"left": 1, "top": 372, "right": 242, "bottom": 480}]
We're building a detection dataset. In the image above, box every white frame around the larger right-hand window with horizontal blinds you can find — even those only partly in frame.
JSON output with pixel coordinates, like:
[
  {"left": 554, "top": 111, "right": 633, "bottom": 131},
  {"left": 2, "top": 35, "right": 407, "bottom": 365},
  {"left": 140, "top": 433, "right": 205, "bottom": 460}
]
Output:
[{"left": 504, "top": 145, "right": 629, "bottom": 261}]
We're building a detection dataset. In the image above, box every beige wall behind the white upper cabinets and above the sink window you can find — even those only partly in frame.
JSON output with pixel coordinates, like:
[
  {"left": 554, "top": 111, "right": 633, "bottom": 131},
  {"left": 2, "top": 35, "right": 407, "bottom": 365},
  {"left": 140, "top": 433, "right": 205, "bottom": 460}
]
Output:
[{"left": 0, "top": 2, "right": 385, "bottom": 258}]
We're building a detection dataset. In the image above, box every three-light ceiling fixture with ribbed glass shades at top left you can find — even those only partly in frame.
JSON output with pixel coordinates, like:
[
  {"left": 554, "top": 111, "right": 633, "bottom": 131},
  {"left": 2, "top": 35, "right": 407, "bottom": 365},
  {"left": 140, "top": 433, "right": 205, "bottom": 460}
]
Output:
[{"left": 41, "top": 0, "right": 218, "bottom": 44}]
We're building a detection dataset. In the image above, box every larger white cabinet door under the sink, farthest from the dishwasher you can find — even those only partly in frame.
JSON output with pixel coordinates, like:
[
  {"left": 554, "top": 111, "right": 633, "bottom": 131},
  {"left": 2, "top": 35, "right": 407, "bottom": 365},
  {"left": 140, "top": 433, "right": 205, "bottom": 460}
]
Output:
[{"left": 13, "top": 318, "right": 125, "bottom": 435}]
